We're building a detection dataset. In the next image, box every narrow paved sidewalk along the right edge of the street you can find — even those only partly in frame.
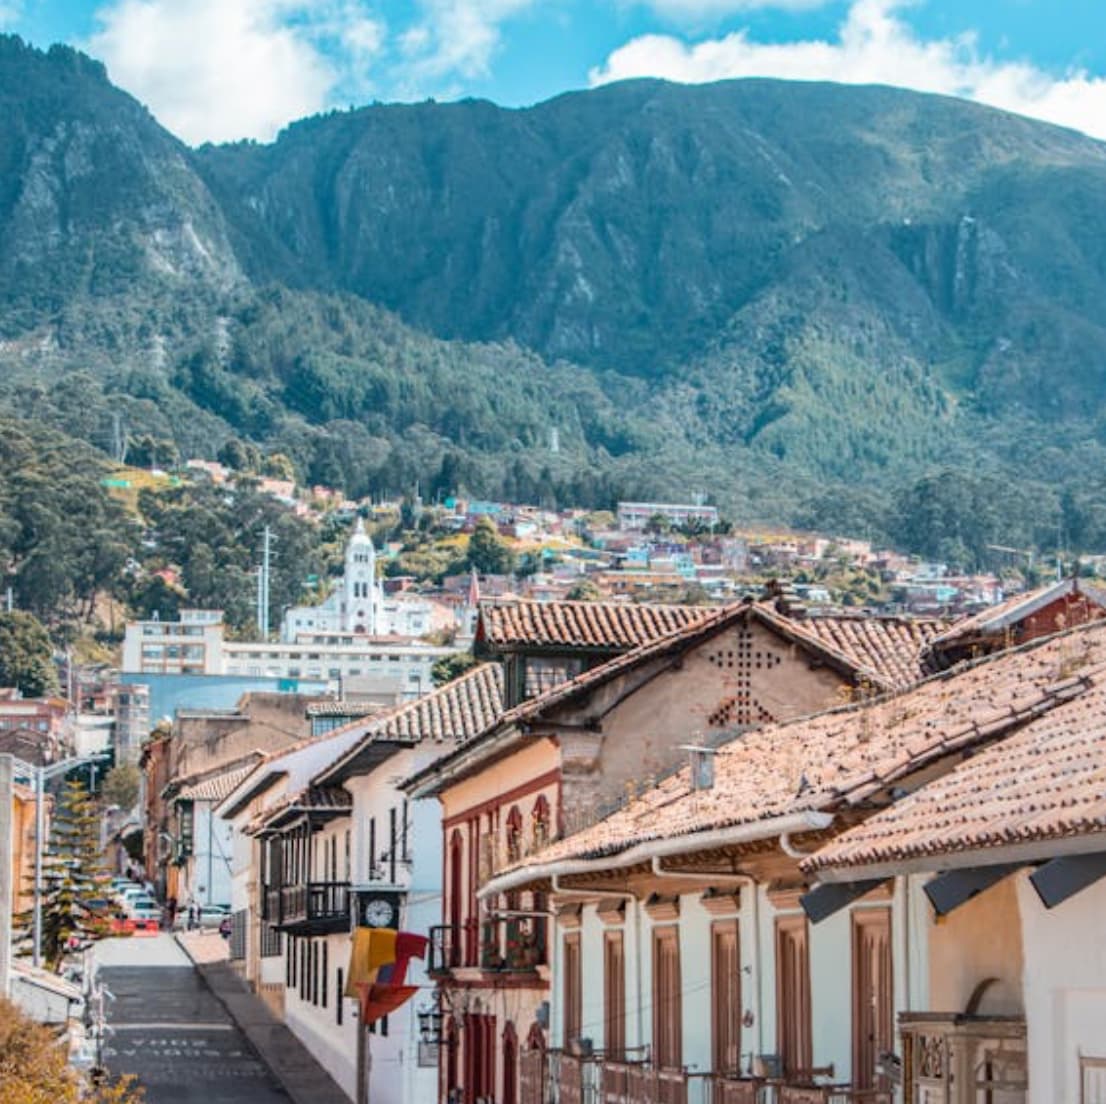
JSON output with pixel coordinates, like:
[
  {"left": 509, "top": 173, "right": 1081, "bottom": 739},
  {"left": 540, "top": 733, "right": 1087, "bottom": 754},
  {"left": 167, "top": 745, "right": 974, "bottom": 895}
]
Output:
[{"left": 177, "top": 933, "right": 349, "bottom": 1104}]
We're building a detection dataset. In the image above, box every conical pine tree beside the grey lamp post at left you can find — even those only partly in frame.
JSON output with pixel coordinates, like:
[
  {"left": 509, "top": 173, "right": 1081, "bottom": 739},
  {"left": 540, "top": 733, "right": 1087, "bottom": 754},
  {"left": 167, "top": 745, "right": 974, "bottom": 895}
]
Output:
[{"left": 21, "top": 781, "right": 112, "bottom": 972}]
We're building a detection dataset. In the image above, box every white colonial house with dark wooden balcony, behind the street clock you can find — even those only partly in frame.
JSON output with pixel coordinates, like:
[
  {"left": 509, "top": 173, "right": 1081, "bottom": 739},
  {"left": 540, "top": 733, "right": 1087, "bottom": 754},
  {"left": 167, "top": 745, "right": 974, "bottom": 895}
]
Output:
[{"left": 221, "top": 664, "right": 502, "bottom": 1104}]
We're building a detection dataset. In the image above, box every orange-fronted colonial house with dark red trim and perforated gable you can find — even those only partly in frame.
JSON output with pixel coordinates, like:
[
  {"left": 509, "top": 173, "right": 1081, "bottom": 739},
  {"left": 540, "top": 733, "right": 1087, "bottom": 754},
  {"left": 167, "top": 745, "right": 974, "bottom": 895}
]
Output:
[{"left": 407, "top": 602, "right": 932, "bottom": 1104}]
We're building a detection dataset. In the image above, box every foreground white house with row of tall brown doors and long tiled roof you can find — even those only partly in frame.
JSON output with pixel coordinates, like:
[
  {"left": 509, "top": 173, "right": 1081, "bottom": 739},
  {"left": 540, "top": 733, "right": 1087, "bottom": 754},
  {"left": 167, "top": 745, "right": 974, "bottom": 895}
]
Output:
[{"left": 486, "top": 623, "right": 1106, "bottom": 1104}]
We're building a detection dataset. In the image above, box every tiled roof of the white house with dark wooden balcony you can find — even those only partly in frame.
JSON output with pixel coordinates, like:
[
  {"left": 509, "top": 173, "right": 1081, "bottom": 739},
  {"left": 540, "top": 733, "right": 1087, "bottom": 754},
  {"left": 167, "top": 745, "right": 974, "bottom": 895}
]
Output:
[{"left": 316, "top": 663, "right": 503, "bottom": 781}]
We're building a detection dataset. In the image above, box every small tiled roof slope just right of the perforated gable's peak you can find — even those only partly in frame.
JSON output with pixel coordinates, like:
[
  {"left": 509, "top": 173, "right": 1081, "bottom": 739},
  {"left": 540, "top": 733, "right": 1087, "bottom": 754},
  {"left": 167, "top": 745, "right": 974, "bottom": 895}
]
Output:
[{"left": 799, "top": 614, "right": 949, "bottom": 689}]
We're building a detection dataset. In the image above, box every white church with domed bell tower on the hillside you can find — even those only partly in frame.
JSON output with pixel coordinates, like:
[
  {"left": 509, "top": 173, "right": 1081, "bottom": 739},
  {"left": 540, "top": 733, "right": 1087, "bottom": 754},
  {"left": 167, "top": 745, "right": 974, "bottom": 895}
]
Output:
[{"left": 281, "top": 518, "right": 436, "bottom": 643}]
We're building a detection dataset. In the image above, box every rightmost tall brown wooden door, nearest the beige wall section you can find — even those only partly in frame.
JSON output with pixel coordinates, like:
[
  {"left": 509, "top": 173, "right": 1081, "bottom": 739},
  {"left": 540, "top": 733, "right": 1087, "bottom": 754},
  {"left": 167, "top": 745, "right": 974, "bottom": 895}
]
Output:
[{"left": 853, "top": 908, "right": 895, "bottom": 1089}]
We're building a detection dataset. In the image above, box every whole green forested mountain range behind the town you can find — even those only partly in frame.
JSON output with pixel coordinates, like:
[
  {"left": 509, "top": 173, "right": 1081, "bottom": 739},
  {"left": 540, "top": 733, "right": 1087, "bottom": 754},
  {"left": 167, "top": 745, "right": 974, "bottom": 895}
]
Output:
[{"left": 0, "top": 38, "right": 1106, "bottom": 566}]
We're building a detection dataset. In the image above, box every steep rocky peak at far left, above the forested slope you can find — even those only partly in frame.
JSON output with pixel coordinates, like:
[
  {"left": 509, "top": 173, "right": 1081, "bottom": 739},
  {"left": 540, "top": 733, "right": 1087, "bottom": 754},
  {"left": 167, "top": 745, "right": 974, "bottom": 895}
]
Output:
[{"left": 0, "top": 39, "right": 241, "bottom": 322}]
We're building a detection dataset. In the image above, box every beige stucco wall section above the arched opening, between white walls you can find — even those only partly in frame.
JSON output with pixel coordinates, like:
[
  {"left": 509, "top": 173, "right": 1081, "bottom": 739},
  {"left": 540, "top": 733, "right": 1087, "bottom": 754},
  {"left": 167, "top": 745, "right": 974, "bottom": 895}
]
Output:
[{"left": 929, "top": 878, "right": 1024, "bottom": 1016}]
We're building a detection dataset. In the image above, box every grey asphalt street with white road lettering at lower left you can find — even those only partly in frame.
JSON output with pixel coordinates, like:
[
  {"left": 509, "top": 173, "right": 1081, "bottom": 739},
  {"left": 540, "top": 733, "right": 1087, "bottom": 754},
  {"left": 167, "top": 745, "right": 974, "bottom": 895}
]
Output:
[{"left": 96, "top": 935, "right": 288, "bottom": 1104}]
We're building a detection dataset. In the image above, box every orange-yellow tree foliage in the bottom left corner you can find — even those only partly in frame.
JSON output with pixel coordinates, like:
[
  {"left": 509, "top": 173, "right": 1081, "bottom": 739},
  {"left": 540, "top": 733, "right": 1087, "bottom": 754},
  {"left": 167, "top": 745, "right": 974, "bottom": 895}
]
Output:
[{"left": 0, "top": 998, "right": 143, "bottom": 1104}]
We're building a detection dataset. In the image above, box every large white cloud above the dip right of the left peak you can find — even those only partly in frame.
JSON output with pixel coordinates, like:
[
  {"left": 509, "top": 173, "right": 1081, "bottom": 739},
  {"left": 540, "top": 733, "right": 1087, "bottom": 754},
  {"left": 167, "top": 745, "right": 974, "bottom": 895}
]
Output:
[{"left": 83, "top": 0, "right": 383, "bottom": 143}]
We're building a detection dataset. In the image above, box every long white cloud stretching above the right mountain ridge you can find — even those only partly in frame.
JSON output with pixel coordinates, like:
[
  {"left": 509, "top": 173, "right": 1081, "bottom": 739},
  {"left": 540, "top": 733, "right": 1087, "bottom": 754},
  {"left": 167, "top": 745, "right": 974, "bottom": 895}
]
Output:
[{"left": 589, "top": 0, "right": 1106, "bottom": 138}]
